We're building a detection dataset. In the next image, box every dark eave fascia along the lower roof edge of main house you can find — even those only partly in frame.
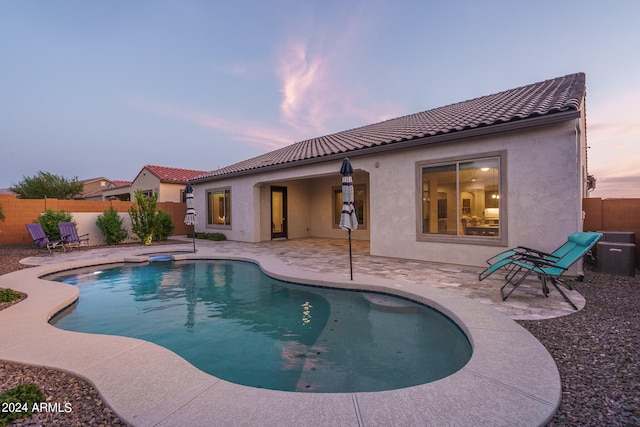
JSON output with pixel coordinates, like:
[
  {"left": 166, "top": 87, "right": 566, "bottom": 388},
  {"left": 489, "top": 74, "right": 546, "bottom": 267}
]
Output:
[{"left": 189, "top": 109, "right": 581, "bottom": 184}]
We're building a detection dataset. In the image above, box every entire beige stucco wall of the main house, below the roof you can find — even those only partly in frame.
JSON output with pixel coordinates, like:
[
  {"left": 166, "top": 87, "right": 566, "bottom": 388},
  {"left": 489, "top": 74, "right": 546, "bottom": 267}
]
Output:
[{"left": 196, "top": 120, "right": 584, "bottom": 266}]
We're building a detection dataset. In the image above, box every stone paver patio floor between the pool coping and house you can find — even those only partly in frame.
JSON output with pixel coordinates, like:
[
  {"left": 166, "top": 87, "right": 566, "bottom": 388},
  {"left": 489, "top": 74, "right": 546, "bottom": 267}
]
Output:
[{"left": 23, "top": 237, "right": 585, "bottom": 320}]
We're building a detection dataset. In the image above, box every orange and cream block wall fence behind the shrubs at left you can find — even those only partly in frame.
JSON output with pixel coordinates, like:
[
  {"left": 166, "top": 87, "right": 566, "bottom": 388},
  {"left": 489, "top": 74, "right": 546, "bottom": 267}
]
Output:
[{"left": 0, "top": 194, "right": 191, "bottom": 246}]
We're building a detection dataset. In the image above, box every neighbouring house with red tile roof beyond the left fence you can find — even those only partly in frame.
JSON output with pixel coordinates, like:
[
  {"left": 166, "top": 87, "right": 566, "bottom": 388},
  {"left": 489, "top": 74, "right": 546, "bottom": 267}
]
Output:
[{"left": 102, "top": 165, "right": 206, "bottom": 203}]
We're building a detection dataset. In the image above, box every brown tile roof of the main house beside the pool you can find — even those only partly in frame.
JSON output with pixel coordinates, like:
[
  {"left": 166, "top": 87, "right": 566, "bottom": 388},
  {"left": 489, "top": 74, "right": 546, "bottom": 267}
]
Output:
[{"left": 192, "top": 73, "right": 586, "bottom": 182}]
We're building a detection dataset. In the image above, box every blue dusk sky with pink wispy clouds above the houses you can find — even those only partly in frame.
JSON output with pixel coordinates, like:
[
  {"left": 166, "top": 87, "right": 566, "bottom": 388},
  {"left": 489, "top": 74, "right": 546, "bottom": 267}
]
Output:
[{"left": 0, "top": 0, "right": 640, "bottom": 198}]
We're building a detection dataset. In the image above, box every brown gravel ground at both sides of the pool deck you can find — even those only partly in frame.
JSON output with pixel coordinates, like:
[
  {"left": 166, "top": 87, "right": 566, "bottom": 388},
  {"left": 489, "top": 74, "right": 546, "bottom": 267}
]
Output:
[{"left": 0, "top": 245, "right": 640, "bottom": 426}]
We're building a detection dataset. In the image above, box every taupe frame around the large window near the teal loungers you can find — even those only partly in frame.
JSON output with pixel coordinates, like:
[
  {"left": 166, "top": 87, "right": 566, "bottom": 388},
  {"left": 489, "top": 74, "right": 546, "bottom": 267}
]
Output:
[{"left": 415, "top": 150, "right": 509, "bottom": 246}]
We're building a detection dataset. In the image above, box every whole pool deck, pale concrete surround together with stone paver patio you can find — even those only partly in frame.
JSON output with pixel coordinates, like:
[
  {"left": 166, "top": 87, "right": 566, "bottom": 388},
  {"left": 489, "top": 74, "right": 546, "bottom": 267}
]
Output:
[{"left": 0, "top": 239, "right": 568, "bottom": 426}]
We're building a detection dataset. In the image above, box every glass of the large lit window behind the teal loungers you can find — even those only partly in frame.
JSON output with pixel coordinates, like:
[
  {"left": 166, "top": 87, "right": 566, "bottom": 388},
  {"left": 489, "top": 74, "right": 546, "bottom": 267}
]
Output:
[{"left": 420, "top": 156, "right": 503, "bottom": 240}]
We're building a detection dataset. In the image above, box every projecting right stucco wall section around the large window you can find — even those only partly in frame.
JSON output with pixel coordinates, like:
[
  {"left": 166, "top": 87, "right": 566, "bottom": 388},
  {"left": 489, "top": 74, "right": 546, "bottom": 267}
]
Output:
[{"left": 360, "top": 122, "right": 582, "bottom": 266}]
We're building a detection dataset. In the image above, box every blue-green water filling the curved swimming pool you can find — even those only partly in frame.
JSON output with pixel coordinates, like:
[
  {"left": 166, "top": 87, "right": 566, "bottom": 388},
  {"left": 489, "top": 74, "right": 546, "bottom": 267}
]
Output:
[{"left": 47, "top": 260, "right": 471, "bottom": 392}]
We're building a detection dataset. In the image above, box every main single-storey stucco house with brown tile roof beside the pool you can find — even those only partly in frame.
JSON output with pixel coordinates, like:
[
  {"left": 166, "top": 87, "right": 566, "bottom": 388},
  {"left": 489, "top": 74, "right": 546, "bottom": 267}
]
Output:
[{"left": 190, "top": 73, "right": 587, "bottom": 266}]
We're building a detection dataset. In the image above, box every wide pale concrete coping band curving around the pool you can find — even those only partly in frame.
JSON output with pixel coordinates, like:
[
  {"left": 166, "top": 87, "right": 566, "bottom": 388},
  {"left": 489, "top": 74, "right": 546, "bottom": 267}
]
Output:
[{"left": 0, "top": 248, "right": 561, "bottom": 426}]
